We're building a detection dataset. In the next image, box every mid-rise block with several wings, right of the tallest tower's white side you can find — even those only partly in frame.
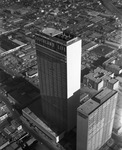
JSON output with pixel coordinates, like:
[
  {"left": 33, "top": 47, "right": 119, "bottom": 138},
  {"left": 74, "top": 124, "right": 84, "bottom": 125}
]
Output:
[{"left": 83, "top": 67, "right": 119, "bottom": 91}]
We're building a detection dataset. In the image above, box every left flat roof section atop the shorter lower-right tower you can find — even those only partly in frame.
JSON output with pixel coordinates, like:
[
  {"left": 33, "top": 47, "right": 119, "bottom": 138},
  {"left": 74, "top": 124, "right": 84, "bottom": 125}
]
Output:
[{"left": 77, "top": 99, "right": 99, "bottom": 116}]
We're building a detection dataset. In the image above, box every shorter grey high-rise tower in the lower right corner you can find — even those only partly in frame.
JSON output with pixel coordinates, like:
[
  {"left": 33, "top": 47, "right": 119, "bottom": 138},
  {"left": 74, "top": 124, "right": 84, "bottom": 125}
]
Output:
[{"left": 77, "top": 88, "right": 118, "bottom": 150}]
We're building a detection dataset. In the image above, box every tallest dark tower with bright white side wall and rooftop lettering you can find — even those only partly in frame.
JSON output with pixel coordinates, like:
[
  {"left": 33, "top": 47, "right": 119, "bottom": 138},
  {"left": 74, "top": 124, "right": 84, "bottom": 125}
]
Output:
[{"left": 36, "top": 28, "right": 81, "bottom": 131}]
